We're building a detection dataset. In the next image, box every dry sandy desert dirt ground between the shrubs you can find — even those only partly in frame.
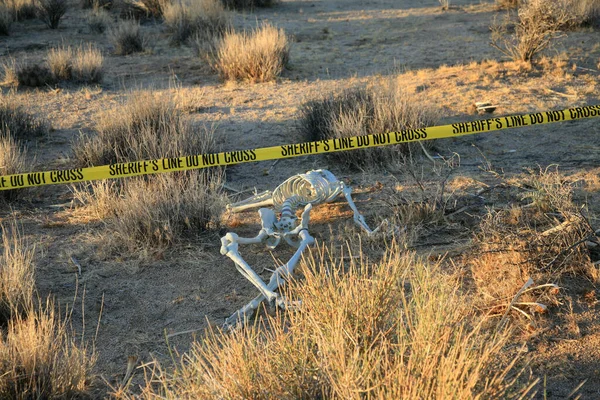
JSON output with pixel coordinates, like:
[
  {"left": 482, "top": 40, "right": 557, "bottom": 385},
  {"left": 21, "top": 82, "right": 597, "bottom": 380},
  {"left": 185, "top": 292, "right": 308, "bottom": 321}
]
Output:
[{"left": 0, "top": 0, "right": 600, "bottom": 399}]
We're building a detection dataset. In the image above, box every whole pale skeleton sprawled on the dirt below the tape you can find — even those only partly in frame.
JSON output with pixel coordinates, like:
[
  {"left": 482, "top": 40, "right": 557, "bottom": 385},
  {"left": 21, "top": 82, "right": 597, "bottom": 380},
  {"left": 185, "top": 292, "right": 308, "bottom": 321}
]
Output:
[{"left": 221, "top": 169, "right": 381, "bottom": 329}]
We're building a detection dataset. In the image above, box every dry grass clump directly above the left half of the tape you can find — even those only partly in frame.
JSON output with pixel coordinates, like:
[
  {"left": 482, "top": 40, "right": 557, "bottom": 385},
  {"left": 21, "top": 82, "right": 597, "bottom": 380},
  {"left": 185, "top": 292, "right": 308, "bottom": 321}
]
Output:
[{"left": 73, "top": 91, "right": 215, "bottom": 166}]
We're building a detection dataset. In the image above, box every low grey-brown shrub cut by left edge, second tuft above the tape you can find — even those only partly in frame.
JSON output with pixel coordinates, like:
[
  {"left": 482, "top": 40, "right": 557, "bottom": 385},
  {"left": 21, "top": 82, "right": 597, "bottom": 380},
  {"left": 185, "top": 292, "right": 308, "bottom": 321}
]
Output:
[{"left": 0, "top": 94, "right": 49, "bottom": 141}]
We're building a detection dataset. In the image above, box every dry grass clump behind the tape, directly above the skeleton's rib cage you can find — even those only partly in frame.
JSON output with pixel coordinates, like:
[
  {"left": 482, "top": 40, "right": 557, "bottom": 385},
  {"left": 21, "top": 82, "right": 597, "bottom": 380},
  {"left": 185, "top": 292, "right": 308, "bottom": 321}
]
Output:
[{"left": 299, "top": 82, "right": 437, "bottom": 169}]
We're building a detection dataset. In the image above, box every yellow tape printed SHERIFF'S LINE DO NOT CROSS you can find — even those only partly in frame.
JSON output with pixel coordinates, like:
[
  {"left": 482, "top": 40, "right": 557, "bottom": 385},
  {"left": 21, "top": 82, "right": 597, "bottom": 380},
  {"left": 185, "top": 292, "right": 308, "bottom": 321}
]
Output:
[{"left": 0, "top": 105, "right": 600, "bottom": 190}]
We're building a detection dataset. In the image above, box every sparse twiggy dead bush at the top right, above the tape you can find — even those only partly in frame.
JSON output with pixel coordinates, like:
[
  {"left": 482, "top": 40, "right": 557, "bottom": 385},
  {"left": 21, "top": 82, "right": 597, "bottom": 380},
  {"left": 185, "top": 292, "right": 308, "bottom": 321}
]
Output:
[{"left": 491, "top": 0, "right": 573, "bottom": 61}]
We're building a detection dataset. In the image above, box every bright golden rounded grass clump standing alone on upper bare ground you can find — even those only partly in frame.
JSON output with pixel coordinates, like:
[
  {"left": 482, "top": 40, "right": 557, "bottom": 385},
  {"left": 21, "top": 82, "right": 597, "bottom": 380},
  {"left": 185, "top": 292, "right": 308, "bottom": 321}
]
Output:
[{"left": 214, "top": 24, "right": 290, "bottom": 82}]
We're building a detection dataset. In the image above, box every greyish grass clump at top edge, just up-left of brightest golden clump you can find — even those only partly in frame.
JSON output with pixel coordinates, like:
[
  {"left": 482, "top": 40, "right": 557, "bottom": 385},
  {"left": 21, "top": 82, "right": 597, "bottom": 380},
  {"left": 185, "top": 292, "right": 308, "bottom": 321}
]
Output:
[{"left": 164, "top": 0, "right": 230, "bottom": 44}]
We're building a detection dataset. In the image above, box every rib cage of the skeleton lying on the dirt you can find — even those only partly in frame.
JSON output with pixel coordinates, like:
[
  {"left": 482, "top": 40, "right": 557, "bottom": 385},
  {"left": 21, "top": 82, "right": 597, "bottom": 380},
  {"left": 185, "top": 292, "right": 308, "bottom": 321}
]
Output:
[{"left": 272, "top": 169, "right": 344, "bottom": 211}]
